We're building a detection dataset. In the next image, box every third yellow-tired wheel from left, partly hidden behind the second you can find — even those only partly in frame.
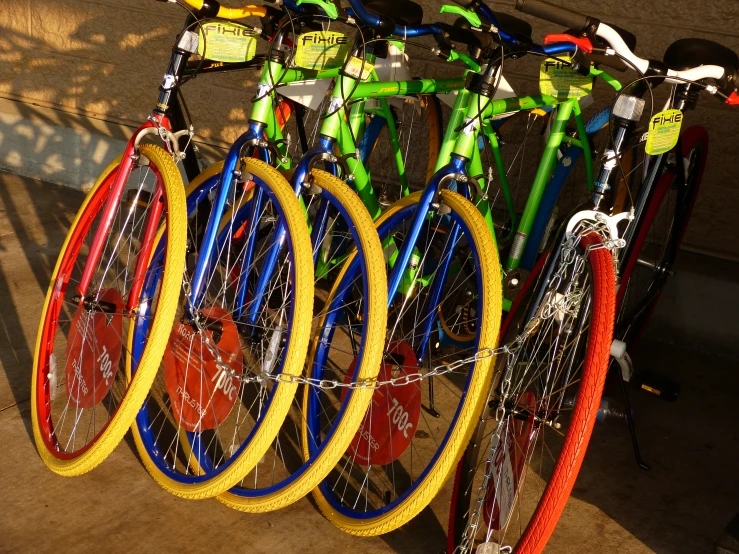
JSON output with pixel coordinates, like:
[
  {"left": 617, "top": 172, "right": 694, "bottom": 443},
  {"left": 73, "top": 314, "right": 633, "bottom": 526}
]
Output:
[{"left": 218, "top": 170, "right": 387, "bottom": 512}]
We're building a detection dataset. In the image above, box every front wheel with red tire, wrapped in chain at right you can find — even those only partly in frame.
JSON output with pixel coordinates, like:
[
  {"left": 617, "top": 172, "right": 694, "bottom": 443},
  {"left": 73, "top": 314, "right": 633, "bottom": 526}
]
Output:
[{"left": 448, "top": 231, "right": 615, "bottom": 554}]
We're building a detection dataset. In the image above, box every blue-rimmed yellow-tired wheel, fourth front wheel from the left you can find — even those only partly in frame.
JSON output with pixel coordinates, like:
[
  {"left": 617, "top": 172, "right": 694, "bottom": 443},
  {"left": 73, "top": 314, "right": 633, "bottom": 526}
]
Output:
[{"left": 305, "top": 191, "right": 501, "bottom": 535}]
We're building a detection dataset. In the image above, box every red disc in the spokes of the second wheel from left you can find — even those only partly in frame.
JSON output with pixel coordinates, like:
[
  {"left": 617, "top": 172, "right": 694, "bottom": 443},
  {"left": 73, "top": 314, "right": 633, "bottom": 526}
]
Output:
[{"left": 164, "top": 307, "right": 244, "bottom": 431}]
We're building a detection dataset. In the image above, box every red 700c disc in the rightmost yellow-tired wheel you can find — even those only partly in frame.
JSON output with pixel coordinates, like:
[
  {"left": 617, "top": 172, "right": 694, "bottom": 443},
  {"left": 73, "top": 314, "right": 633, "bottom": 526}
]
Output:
[{"left": 342, "top": 342, "right": 421, "bottom": 466}]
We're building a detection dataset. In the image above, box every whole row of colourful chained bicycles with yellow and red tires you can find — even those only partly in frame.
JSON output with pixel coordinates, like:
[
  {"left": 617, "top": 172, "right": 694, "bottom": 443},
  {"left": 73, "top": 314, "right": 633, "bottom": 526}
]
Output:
[{"left": 32, "top": 0, "right": 739, "bottom": 554}]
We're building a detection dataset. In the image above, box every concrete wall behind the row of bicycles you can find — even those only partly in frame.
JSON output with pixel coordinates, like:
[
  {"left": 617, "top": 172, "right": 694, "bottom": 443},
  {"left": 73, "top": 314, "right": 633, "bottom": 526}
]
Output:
[{"left": 0, "top": 0, "right": 739, "bottom": 254}]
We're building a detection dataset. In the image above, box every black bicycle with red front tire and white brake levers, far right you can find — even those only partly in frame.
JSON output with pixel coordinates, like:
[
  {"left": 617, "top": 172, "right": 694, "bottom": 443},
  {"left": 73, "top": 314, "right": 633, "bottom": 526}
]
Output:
[{"left": 448, "top": 0, "right": 739, "bottom": 552}]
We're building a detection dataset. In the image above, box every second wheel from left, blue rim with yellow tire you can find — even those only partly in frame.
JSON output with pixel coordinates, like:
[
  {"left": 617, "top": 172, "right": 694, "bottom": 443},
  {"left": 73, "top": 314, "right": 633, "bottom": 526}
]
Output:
[{"left": 129, "top": 158, "right": 313, "bottom": 498}]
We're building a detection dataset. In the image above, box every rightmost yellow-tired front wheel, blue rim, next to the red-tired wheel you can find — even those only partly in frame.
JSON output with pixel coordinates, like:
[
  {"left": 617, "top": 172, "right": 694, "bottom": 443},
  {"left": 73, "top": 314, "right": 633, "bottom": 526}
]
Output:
[{"left": 310, "top": 190, "right": 501, "bottom": 536}]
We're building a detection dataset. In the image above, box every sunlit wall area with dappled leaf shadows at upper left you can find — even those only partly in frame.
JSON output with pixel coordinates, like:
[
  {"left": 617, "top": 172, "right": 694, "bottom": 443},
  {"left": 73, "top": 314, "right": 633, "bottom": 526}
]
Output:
[{"left": 0, "top": 1, "right": 254, "bottom": 189}]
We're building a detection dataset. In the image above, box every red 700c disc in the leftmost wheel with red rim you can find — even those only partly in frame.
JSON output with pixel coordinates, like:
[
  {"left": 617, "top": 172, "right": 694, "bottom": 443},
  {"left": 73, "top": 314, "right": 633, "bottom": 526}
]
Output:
[{"left": 65, "top": 289, "right": 123, "bottom": 408}]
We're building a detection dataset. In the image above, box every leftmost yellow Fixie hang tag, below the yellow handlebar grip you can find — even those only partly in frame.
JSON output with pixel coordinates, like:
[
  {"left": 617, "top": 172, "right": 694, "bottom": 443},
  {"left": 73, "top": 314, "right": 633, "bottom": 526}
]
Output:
[{"left": 198, "top": 21, "right": 258, "bottom": 63}]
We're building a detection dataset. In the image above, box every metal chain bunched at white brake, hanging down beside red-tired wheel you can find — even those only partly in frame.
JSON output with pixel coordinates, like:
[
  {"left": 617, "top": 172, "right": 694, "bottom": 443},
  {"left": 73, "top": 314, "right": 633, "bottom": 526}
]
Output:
[{"left": 454, "top": 220, "right": 623, "bottom": 554}]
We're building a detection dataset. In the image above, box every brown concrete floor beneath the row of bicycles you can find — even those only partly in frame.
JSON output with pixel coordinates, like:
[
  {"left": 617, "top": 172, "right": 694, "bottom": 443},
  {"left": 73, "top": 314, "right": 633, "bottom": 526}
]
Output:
[{"left": 0, "top": 170, "right": 739, "bottom": 554}]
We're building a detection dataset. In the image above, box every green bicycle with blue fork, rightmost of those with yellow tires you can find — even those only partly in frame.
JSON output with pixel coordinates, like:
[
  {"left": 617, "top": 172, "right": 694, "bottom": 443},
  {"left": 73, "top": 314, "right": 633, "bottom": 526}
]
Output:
[{"left": 280, "top": 2, "right": 616, "bottom": 535}]
